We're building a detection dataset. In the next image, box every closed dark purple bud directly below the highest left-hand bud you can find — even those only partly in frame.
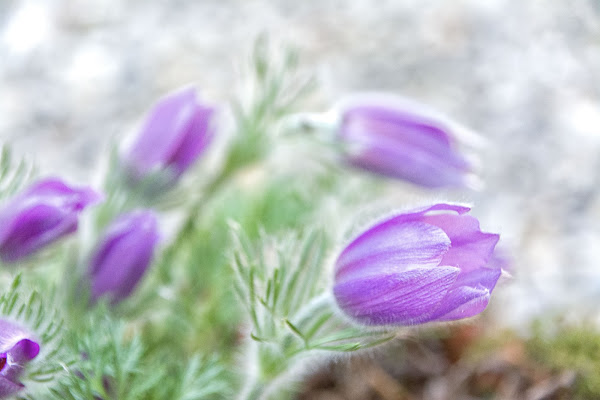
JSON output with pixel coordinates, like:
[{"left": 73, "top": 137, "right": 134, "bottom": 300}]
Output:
[{"left": 88, "top": 210, "right": 159, "bottom": 303}]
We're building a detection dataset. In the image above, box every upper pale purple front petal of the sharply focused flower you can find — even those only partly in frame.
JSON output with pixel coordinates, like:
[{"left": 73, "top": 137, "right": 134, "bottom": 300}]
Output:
[{"left": 336, "top": 219, "right": 450, "bottom": 282}]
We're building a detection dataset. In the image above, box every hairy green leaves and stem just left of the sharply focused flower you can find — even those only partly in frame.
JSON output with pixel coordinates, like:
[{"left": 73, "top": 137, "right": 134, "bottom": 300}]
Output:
[{"left": 231, "top": 224, "right": 394, "bottom": 398}]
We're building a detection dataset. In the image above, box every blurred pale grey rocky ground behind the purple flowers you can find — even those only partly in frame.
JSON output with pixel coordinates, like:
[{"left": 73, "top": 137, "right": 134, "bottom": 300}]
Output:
[{"left": 0, "top": 0, "right": 600, "bottom": 324}]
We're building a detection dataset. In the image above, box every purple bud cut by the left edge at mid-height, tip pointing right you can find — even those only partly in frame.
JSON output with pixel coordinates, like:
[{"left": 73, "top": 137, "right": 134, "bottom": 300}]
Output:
[{"left": 0, "top": 179, "right": 101, "bottom": 262}]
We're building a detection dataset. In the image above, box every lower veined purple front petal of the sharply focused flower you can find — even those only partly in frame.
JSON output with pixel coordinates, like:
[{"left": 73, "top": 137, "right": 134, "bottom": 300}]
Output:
[{"left": 333, "top": 267, "right": 460, "bottom": 325}]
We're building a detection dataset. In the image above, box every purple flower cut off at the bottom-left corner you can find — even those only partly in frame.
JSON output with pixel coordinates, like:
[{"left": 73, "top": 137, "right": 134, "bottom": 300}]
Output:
[{"left": 0, "top": 319, "right": 40, "bottom": 399}]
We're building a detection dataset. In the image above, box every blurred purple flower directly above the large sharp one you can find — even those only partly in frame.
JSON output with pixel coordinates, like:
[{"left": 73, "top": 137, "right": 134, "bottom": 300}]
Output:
[{"left": 339, "top": 96, "right": 471, "bottom": 188}]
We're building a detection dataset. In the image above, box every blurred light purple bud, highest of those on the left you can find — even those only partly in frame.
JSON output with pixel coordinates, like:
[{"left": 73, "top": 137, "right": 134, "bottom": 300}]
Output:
[{"left": 124, "top": 88, "right": 215, "bottom": 179}]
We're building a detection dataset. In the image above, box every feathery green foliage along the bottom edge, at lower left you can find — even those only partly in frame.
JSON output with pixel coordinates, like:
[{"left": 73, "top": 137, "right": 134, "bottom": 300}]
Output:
[{"left": 54, "top": 306, "right": 230, "bottom": 400}]
